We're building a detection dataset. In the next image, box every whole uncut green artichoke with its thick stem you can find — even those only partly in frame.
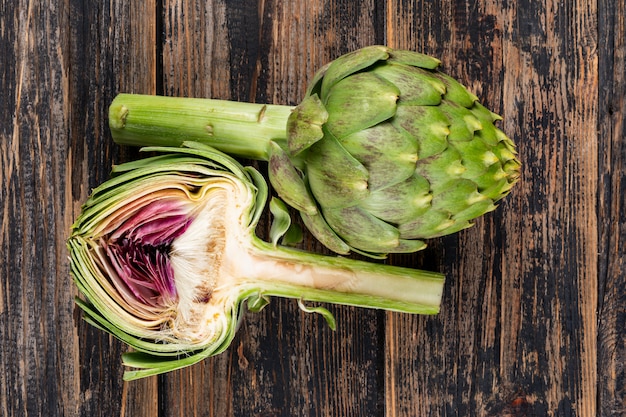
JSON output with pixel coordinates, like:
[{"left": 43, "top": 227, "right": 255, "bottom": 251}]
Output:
[{"left": 110, "top": 46, "right": 520, "bottom": 257}]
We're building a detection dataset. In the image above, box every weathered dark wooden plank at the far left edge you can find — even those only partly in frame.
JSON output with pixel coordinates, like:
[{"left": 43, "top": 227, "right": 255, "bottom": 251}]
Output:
[{"left": 0, "top": 1, "right": 156, "bottom": 416}]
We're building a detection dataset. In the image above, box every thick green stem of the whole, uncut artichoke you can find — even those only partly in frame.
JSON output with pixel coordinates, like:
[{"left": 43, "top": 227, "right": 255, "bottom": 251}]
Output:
[{"left": 109, "top": 94, "right": 293, "bottom": 161}]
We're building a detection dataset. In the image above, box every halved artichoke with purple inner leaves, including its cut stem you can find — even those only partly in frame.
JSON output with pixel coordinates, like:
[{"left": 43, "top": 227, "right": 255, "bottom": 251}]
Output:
[{"left": 68, "top": 142, "right": 443, "bottom": 379}]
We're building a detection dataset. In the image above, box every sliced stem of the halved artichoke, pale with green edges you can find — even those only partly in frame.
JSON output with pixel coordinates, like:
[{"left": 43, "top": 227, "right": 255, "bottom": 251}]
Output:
[{"left": 238, "top": 240, "right": 444, "bottom": 314}]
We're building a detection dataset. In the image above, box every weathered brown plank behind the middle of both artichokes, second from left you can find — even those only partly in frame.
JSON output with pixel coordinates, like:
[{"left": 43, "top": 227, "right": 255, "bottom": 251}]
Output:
[{"left": 156, "top": 1, "right": 384, "bottom": 416}]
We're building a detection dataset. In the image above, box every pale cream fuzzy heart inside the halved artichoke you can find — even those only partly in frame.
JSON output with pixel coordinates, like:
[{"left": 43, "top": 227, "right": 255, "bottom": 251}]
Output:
[{"left": 170, "top": 176, "right": 254, "bottom": 345}]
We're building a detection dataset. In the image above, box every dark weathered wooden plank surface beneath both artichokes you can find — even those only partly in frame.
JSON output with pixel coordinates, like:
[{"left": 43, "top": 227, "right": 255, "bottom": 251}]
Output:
[{"left": 0, "top": 0, "right": 626, "bottom": 417}]
